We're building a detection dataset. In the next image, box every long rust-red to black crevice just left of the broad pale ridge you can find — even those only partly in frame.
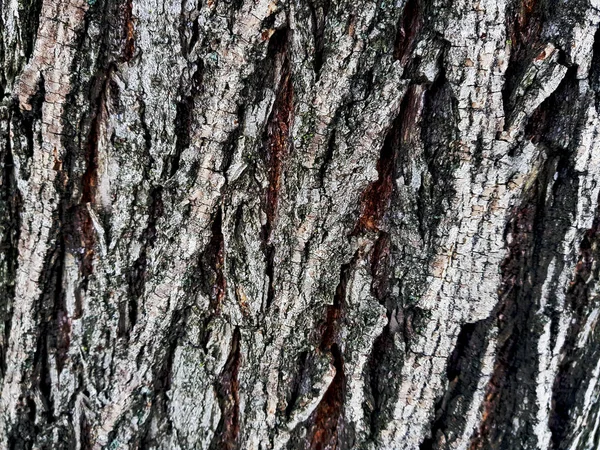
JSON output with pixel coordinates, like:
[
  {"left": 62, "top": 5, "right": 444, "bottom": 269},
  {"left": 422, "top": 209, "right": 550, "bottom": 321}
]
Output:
[{"left": 364, "top": 85, "right": 426, "bottom": 441}]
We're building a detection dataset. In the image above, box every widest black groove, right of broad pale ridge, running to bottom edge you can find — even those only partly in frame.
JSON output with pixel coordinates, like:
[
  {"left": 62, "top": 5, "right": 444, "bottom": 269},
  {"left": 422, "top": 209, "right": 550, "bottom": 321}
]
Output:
[{"left": 470, "top": 68, "right": 581, "bottom": 442}]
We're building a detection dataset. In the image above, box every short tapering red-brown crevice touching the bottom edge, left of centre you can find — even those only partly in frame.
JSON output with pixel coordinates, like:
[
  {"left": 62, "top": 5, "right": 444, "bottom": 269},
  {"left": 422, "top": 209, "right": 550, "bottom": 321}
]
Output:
[{"left": 209, "top": 328, "right": 242, "bottom": 450}]
